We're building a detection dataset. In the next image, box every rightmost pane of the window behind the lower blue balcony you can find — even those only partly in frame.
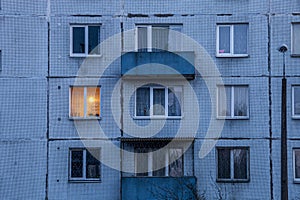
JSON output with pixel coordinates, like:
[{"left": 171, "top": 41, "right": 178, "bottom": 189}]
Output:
[{"left": 169, "top": 149, "right": 183, "bottom": 177}]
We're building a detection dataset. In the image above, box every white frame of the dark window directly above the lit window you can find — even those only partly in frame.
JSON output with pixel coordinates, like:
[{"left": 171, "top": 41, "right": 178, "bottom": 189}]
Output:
[{"left": 70, "top": 24, "right": 101, "bottom": 57}]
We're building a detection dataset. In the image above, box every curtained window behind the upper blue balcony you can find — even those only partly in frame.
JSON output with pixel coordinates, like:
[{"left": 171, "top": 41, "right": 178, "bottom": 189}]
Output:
[{"left": 136, "top": 25, "right": 182, "bottom": 51}]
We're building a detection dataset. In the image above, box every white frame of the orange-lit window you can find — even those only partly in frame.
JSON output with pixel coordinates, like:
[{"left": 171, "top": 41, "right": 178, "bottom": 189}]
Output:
[{"left": 69, "top": 85, "right": 102, "bottom": 119}]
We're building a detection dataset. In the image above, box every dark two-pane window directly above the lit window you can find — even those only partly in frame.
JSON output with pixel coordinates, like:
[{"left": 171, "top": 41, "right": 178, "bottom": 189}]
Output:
[{"left": 70, "top": 25, "right": 100, "bottom": 57}]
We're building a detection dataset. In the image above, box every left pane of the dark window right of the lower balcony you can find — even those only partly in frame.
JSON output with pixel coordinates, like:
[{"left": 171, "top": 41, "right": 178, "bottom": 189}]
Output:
[{"left": 218, "top": 149, "right": 230, "bottom": 179}]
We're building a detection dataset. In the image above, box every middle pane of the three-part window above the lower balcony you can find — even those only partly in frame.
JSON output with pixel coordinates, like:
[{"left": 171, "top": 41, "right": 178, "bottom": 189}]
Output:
[{"left": 152, "top": 151, "right": 166, "bottom": 176}]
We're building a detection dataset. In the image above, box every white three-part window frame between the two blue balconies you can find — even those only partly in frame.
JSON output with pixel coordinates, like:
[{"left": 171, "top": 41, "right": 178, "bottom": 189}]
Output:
[{"left": 134, "top": 86, "right": 184, "bottom": 119}]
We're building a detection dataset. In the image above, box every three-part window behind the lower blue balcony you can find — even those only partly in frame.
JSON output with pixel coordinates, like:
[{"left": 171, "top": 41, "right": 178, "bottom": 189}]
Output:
[{"left": 135, "top": 148, "right": 183, "bottom": 177}]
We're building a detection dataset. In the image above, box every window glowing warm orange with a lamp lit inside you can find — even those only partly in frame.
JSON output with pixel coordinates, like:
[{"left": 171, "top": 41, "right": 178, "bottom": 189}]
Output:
[{"left": 69, "top": 86, "right": 100, "bottom": 118}]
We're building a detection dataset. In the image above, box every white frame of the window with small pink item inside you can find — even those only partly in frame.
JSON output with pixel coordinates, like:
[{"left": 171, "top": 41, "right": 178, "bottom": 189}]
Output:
[{"left": 216, "top": 23, "right": 249, "bottom": 57}]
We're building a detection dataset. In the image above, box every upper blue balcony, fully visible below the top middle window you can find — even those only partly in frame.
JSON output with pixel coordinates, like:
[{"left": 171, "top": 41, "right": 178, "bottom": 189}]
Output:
[{"left": 121, "top": 51, "right": 195, "bottom": 79}]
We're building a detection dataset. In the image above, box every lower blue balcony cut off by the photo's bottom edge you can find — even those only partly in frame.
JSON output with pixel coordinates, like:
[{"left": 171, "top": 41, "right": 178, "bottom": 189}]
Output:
[{"left": 122, "top": 176, "right": 197, "bottom": 200}]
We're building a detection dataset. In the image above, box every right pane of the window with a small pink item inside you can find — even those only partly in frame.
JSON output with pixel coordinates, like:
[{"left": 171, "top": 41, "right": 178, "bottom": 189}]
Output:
[{"left": 233, "top": 24, "right": 248, "bottom": 54}]
